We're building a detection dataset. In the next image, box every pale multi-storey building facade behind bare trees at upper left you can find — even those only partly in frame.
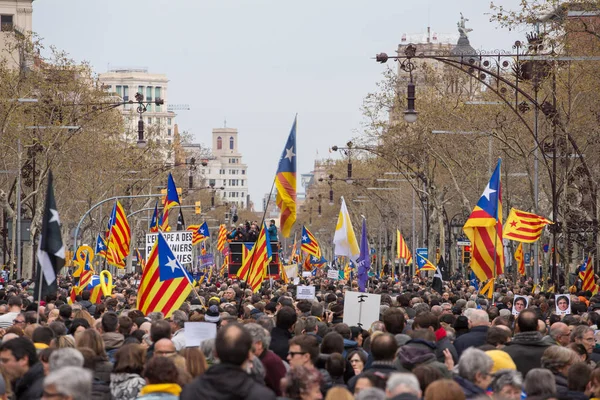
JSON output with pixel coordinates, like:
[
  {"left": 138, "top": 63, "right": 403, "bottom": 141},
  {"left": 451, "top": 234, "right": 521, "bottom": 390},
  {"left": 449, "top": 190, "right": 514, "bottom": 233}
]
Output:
[{"left": 98, "top": 68, "right": 176, "bottom": 152}]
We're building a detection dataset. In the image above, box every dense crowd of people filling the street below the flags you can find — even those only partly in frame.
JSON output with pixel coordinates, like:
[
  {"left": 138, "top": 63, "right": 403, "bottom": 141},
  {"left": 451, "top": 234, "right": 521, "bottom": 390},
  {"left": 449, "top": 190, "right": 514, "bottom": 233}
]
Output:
[{"left": 0, "top": 270, "right": 600, "bottom": 400}]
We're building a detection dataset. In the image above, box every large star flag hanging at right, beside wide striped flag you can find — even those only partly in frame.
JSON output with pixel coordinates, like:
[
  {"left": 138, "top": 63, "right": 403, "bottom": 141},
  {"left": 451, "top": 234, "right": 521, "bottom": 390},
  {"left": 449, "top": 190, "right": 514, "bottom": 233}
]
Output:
[{"left": 463, "top": 160, "right": 504, "bottom": 282}]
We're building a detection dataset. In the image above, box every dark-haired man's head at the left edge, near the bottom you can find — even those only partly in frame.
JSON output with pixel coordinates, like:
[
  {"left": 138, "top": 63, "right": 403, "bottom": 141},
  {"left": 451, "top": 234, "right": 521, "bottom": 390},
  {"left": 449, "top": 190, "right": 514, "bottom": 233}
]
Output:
[{"left": 0, "top": 337, "right": 38, "bottom": 381}]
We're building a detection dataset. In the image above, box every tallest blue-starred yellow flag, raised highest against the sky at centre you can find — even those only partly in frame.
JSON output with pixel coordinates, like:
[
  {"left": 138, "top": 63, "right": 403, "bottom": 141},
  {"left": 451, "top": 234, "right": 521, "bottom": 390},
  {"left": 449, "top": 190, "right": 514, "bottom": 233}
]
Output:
[{"left": 275, "top": 118, "right": 296, "bottom": 237}]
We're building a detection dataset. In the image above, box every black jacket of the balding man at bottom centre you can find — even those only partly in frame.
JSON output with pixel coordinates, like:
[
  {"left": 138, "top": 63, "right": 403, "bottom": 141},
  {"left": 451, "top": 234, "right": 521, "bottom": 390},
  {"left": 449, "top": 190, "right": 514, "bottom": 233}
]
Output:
[{"left": 179, "top": 364, "right": 276, "bottom": 400}]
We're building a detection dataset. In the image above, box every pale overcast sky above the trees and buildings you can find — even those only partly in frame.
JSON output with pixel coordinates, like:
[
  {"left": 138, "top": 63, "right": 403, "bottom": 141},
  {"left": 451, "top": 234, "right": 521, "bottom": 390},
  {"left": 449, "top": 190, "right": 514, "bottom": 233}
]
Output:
[{"left": 33, "top": 0, "right": 524, "bottom": 210}]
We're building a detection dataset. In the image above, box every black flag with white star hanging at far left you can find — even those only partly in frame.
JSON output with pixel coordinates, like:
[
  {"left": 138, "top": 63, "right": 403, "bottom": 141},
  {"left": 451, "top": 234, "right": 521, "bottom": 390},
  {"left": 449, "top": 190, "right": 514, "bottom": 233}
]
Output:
[{"left": 34, "top": 171, "right": 65, "bottom": 300}]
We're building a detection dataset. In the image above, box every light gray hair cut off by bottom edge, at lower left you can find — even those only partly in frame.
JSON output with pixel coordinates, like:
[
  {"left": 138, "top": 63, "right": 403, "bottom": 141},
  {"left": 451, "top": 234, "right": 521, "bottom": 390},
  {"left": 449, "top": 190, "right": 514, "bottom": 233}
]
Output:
[{"left": 44, "top": 367, "right": 92, "bottom": 400}]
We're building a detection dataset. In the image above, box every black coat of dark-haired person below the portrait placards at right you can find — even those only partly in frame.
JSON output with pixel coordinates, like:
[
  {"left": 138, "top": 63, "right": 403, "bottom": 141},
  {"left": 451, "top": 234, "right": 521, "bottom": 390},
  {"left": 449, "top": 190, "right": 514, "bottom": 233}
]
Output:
[{"left": 502, "top": 332, "right": 550, "bottom": 376}]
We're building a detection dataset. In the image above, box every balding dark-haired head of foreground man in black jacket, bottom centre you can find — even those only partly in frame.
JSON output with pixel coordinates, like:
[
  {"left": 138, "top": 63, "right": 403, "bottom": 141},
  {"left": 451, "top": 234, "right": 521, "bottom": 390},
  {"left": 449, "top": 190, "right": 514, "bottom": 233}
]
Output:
[{"left": 215, "top": 323, "right": 252, "bottom": 366}]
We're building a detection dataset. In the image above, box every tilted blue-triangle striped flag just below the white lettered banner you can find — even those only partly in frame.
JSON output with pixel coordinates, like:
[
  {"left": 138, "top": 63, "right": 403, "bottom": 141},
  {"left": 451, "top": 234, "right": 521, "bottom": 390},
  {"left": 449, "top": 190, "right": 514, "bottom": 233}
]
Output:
[{"left": 137, "top": 232, "right": 192, "bottom": 317}]
